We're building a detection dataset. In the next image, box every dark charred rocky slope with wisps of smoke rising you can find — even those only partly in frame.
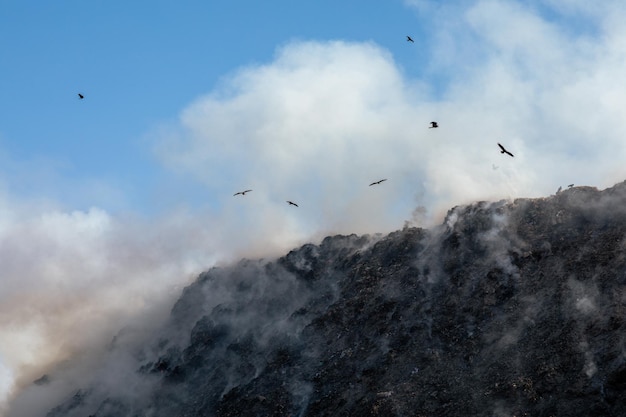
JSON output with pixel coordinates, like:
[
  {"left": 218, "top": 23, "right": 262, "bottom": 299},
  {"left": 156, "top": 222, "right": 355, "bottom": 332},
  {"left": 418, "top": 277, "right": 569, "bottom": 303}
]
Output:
[{"left": 12, "top": 183, "right": 626, "bottom": 417}]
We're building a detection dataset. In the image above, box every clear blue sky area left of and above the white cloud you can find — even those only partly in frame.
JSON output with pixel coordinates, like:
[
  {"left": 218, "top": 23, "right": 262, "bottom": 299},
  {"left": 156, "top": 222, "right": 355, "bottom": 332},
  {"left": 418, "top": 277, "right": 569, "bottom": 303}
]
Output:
[{"left": 0, "top": 1, "right": 426, "bottom": 211}]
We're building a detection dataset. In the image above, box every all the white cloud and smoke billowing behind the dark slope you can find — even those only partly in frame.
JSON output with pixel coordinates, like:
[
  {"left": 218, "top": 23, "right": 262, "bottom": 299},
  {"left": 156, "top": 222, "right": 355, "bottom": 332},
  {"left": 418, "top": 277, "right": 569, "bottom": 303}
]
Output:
[{"left": 0, "top": 1, "right": 626, "bottom": 414}]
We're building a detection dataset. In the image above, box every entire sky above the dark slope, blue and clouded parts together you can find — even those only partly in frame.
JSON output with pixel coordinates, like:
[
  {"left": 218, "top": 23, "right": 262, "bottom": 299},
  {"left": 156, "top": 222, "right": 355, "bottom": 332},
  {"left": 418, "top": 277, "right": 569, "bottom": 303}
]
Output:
[{"left": 0, "top": 0, "right": 626, "bottom": 414}]
